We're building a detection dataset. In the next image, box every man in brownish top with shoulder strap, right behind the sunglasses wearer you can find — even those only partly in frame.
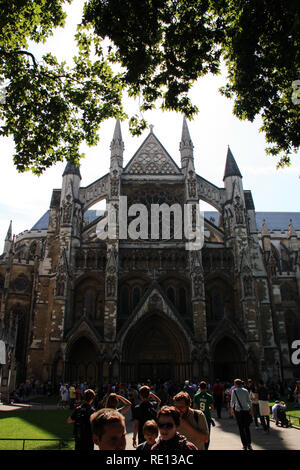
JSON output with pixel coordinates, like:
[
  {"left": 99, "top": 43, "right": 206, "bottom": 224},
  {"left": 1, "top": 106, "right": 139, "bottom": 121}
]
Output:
[{"left": 173, "top": 392, "right": 209, "bottom": 450}]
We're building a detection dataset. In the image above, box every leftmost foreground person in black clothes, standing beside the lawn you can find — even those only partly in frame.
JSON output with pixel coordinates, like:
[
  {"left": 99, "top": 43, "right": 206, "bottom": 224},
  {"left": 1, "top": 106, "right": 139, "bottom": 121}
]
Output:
[{"left": 67, "top": 389, "right": 96, "bottom": 450}]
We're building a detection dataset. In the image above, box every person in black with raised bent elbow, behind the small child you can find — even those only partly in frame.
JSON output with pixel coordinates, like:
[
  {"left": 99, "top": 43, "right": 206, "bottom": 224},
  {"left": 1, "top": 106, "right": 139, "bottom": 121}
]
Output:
[{"left": 132, "top": 385, "right": 161, "bottom": 447}]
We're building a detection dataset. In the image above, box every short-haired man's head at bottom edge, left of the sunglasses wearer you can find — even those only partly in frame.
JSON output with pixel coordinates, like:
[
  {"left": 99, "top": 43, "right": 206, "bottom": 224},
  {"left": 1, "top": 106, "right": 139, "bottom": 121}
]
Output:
[{"left": 90, "top": 408, "right": 126, "bottom": 450}]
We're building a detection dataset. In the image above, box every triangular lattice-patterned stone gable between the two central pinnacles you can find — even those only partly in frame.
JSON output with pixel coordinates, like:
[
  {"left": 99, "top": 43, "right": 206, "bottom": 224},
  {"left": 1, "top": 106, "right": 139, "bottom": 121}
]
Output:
[{"left": 124, "top": 132, "right": 181, "bottom": 175}]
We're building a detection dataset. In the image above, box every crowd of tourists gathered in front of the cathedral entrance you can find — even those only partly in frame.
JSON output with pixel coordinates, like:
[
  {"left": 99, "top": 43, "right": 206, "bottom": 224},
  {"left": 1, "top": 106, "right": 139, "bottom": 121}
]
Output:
[{"left": 63, "top": 379, "right": 300, "bottom": 452}]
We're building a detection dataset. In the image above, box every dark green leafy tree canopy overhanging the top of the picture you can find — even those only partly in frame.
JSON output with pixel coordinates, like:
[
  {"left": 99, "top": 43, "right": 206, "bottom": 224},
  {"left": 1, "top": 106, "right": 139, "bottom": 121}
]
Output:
[{"left": 0, "top": 0, "right": 300, "bottom": 174}]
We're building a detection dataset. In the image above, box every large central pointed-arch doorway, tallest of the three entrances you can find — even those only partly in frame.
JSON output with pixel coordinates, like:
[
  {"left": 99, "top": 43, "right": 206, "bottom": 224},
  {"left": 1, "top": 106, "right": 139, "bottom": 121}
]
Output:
[{"left": 122, "top": 313, "right": 191, "bottom": 382}]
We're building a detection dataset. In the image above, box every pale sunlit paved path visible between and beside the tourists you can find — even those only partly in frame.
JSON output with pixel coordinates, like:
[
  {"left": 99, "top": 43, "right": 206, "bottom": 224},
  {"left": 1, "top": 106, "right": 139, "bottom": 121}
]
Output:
[{"left": 0, "top": 404, "right": 300, "bottom": 450}]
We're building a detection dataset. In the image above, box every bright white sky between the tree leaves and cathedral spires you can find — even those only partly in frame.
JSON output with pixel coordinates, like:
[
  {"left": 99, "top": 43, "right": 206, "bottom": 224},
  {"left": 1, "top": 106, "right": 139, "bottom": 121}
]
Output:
[{"left": 0, "top": 0, "right": 300, "bottom": 252}]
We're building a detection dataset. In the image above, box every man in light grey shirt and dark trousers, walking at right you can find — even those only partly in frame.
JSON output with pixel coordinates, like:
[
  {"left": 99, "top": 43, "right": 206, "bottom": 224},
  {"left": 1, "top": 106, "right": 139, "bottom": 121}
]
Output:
[{"left": 230, "top": 379, "right": 253, "bottom": 450}]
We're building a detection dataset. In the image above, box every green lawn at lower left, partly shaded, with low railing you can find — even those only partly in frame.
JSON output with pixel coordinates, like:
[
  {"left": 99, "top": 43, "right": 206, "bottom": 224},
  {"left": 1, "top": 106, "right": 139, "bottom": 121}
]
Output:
[{"left": 0, "top": 410, "right": 74, "bottom": 450}]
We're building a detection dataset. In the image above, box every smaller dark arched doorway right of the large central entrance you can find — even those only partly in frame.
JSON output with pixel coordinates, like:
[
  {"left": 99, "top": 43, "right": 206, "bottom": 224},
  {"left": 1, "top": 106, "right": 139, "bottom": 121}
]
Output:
[{"left": 213, "top": 336, "right": 246, "bottom": 381}]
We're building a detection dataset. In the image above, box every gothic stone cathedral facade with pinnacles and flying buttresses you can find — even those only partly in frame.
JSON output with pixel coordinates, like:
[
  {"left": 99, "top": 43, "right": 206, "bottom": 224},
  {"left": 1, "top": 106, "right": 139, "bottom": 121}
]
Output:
[{"left": 0, "top": 119, "right": 300, "bottom": 393}]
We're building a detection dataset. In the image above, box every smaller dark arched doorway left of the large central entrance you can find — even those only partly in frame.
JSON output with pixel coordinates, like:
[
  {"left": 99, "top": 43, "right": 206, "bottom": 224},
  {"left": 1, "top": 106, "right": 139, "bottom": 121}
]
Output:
[{"left": 65, "top": 337, "right": 99, "bottom": 387}]
